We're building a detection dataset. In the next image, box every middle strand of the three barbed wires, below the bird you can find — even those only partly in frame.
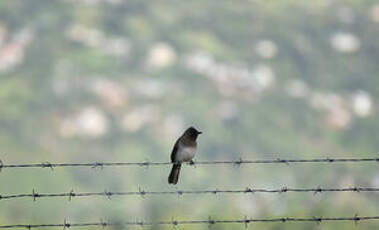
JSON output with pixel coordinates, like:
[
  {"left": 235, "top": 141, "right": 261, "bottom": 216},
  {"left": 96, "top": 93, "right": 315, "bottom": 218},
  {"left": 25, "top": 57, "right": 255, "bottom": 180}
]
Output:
[{"left": 0, "top": 186, "right": 379, "bottom": 201}]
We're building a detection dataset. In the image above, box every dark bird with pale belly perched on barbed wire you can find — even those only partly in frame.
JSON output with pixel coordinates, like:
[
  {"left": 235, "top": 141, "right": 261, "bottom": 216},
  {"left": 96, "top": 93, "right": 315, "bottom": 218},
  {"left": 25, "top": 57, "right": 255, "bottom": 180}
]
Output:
[{"left": 168, "top": 126, "right": 201, "bottom": 184}]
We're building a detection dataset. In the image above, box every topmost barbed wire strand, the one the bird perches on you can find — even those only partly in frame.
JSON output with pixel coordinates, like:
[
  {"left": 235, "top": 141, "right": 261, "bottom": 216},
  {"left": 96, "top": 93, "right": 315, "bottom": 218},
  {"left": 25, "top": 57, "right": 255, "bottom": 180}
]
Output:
[{"left": 0, "top": 157, "right": 379, "bottom": 171}]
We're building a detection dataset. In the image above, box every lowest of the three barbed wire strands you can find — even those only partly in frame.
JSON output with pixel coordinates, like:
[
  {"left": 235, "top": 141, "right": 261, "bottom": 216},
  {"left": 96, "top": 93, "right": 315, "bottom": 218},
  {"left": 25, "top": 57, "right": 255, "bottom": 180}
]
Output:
[{"left": 0, "top": 215, "right": 379, "bottom": 229}]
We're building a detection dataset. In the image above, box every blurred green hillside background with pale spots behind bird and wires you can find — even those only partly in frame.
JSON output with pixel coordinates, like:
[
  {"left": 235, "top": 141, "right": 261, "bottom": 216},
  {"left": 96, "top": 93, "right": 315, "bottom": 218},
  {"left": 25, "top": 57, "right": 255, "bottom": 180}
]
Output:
[{"left": 0, "top": 0, "right": 379, "bottom": 230}]
